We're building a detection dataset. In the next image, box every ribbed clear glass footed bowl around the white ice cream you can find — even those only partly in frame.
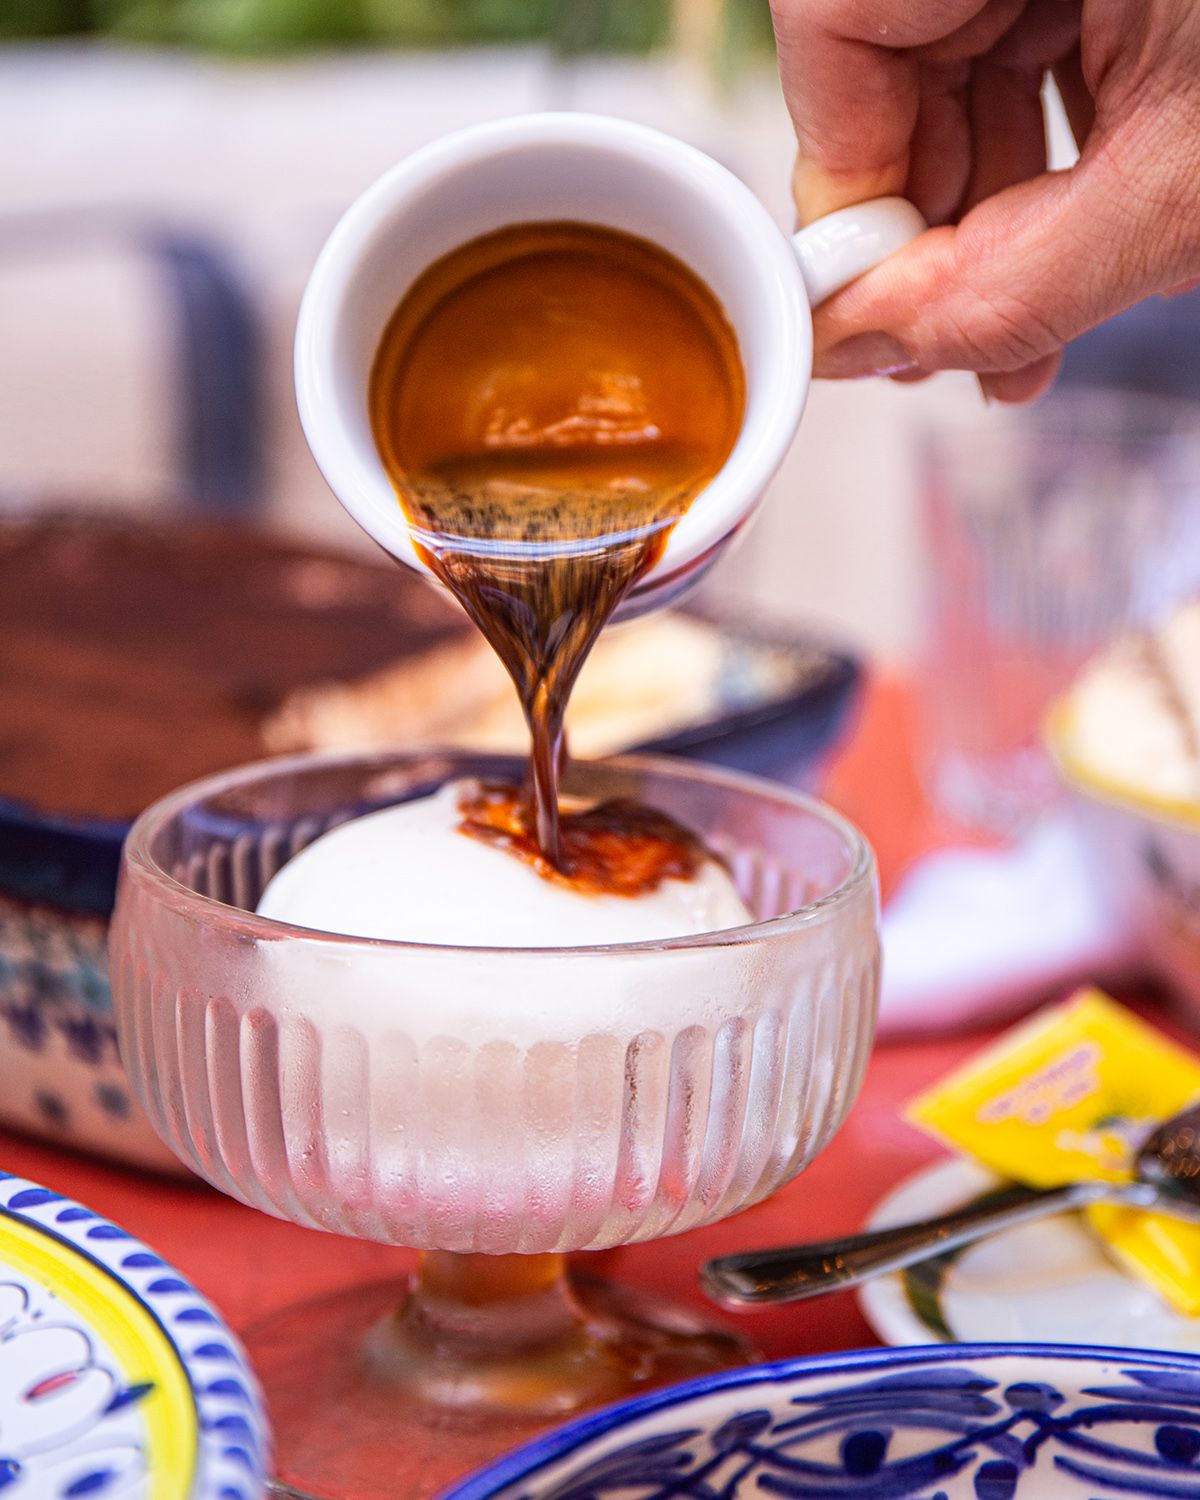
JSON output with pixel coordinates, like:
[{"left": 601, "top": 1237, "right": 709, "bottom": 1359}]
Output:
[{"left": 111, "top": 753, "right": 879, "bottom": 1497}]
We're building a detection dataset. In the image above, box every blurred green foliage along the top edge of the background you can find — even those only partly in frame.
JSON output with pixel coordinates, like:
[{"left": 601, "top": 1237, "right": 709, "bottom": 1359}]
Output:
[{"left": 0, "top": 0, "right": 771, "bottom": 57}]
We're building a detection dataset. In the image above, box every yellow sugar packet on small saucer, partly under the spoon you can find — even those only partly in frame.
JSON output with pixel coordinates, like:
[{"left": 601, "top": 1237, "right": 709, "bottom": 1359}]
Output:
[{"left": 908, "top": 989, "right": 1200, "bottom": 1316}]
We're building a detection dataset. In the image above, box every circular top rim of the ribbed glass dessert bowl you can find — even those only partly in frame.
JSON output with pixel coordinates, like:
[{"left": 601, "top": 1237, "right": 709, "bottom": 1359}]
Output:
[{"left": 119, "top": 746, "right": 876, "bottom": 962}]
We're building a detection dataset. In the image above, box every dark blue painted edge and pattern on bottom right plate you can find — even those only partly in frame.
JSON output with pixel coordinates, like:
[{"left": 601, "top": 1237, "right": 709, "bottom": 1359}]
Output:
[{"left": 441, "top": 1344, "right": 1200, "bottom": 1500}]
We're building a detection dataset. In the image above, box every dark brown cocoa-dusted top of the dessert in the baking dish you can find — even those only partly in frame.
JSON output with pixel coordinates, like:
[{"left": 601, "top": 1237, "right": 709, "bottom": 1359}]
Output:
[{"left": 0, "top": 515, "right": 467, "bottom": 819}]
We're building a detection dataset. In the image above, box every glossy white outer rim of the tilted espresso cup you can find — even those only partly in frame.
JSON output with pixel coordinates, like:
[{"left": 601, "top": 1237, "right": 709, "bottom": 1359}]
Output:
[{"left": 296, "top": 113, "right": 812, "bottom": 596}]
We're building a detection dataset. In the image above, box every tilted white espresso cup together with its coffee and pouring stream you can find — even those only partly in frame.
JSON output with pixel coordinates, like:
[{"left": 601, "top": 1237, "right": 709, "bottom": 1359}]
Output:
[{"left": 296, "top": 114, "right": 923, "bottom": 884}]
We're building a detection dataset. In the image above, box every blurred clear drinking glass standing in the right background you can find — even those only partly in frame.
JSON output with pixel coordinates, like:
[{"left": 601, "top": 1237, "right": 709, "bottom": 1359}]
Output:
[{"left": 923, "top": 389, "right": 1200, "bottom": 834}]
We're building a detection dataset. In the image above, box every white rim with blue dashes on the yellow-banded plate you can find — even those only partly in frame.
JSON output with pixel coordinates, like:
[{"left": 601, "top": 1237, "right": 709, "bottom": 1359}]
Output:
[{"left": 0, "top": 1172, "right": 270, "bottom": 1500}]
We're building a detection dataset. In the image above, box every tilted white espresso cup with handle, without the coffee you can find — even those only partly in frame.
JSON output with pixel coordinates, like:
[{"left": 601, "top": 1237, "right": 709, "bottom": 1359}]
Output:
[{"left": 296, "top": 114, "right": 924, "bottom": 617}]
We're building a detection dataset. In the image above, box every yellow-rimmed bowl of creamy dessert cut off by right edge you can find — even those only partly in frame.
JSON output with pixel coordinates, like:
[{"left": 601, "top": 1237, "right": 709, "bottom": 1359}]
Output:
[{"left": 1047, "top": 600, "right": 1200, "bottom": 1022}]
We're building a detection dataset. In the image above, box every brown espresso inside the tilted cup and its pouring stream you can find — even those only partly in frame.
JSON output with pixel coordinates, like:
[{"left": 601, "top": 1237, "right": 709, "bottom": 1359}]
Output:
[{"left": 371, "top": 224, "right": 744, "bottom": 884}]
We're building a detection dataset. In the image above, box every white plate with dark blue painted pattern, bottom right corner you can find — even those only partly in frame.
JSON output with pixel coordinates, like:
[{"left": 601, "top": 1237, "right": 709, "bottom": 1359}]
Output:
[{"left": 444, "top": 1344, "right": 1200, "bottom": 1500}]
